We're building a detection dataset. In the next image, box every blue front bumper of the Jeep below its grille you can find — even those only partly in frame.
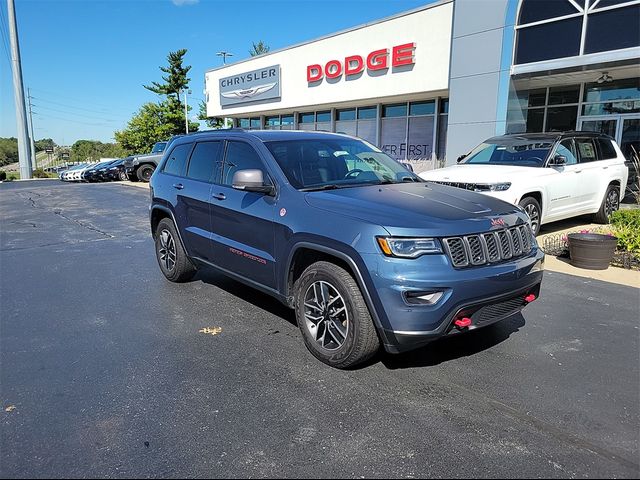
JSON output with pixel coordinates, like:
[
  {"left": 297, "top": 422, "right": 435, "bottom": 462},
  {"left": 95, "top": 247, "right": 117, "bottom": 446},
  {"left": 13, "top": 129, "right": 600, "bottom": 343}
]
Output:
[{"left": 363, "top": 248, "right": 544, "bottom": 353}]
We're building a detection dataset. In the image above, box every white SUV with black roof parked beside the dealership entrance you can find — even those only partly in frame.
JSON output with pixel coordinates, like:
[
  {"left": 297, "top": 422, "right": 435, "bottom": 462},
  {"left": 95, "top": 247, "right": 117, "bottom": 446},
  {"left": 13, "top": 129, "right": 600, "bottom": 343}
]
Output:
[{"left": 419, "top": 132, "right": 629, "bottom": 234}]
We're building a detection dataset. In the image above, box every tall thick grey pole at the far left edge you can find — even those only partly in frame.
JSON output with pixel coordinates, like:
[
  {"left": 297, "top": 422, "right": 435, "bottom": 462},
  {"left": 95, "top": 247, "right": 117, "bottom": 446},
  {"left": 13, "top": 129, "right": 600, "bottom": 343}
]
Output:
[{"left": 7, "top": 0, "right": 32, "bottom": 179}]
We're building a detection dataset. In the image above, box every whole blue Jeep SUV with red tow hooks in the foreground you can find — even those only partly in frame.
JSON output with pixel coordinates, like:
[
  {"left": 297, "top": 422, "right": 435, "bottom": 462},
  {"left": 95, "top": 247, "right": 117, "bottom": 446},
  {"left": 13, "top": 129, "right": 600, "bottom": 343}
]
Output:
[{"left": 150, "top": 129, "right": 544, "bottom": 368}]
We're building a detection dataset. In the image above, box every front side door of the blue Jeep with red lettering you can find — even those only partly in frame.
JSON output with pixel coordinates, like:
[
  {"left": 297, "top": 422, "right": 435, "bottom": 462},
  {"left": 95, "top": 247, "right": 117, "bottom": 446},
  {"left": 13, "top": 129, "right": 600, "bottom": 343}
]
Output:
[{"left": 211, "top": 139, "right": 276, "bottom": 288}]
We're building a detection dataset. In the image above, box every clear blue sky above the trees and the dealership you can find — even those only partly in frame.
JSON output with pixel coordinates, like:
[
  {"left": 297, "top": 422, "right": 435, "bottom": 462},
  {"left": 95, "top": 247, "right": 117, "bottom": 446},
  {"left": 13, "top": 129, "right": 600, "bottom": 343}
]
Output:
[{"left": 0, "top": 0, "right": 433, "bottom": 145}]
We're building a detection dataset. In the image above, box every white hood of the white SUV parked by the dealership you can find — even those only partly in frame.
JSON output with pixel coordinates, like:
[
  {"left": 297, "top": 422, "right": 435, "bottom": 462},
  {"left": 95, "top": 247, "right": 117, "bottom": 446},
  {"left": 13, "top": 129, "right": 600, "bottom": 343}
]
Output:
[{"left": 420, "top": 164, "right": 548, "bottom": 183}]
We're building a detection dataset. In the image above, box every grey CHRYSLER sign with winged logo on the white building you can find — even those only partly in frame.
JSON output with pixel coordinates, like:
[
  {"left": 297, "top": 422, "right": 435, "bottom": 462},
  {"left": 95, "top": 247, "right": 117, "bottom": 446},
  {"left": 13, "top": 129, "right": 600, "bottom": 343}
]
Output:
[{"left": 219, "top": 65, "right": 280, "bottom": 107}]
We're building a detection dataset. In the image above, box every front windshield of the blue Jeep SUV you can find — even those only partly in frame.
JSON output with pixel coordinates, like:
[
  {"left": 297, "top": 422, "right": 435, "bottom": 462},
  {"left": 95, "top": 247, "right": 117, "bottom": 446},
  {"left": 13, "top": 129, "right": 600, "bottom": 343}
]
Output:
[{"left": 266, "top": 138, "right": 421, "bottom": 190}]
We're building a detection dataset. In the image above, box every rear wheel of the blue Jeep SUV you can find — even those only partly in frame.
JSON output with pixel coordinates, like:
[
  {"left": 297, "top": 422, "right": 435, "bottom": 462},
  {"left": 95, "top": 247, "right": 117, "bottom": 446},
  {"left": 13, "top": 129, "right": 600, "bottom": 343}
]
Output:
[{"left": 156, "top": 218, "right": 196, "bottom": 283}]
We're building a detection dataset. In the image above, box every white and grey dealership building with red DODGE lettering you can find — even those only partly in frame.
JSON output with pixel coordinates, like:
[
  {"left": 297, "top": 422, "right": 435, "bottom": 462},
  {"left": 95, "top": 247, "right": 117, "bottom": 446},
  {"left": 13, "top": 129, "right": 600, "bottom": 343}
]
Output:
[{"left": 205, "top": 0, "right": 640, "bottom": 169}]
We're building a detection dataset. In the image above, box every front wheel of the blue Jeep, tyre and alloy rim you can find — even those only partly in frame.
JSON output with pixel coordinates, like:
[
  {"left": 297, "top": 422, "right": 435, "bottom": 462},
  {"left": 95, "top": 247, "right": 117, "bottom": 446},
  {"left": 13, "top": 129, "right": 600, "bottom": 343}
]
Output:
[{"left": 295, "top": 262, "right": 380, "bottom": 368}]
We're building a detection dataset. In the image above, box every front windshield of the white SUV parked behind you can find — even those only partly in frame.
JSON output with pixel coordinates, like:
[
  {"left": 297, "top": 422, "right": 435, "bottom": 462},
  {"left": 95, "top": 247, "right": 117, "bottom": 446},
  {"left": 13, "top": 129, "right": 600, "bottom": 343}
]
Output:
[{"left": 462, "top": 139, "right": 554, "bottom": 167}]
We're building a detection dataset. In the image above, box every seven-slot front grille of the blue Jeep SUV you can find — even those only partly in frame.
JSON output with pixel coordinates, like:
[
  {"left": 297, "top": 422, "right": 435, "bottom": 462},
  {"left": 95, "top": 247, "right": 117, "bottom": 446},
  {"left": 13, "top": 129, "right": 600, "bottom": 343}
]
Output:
[{"left": 442, "top": 225, "right": 535, "bottom": 268}]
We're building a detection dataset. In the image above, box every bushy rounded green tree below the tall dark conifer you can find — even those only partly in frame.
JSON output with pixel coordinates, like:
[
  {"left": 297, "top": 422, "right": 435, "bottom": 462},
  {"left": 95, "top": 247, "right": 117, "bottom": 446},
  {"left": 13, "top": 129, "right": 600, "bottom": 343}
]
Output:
[{"left": 114, "top": 97, "right": 198, "bottom": 153}]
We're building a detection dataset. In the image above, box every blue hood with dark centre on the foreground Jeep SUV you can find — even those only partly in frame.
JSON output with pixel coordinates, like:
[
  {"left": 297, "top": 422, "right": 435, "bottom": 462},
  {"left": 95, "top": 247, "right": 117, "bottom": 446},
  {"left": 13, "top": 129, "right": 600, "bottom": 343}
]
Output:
[{"left": 305, "top": 183, "right": 527, "bottom": 236}]
